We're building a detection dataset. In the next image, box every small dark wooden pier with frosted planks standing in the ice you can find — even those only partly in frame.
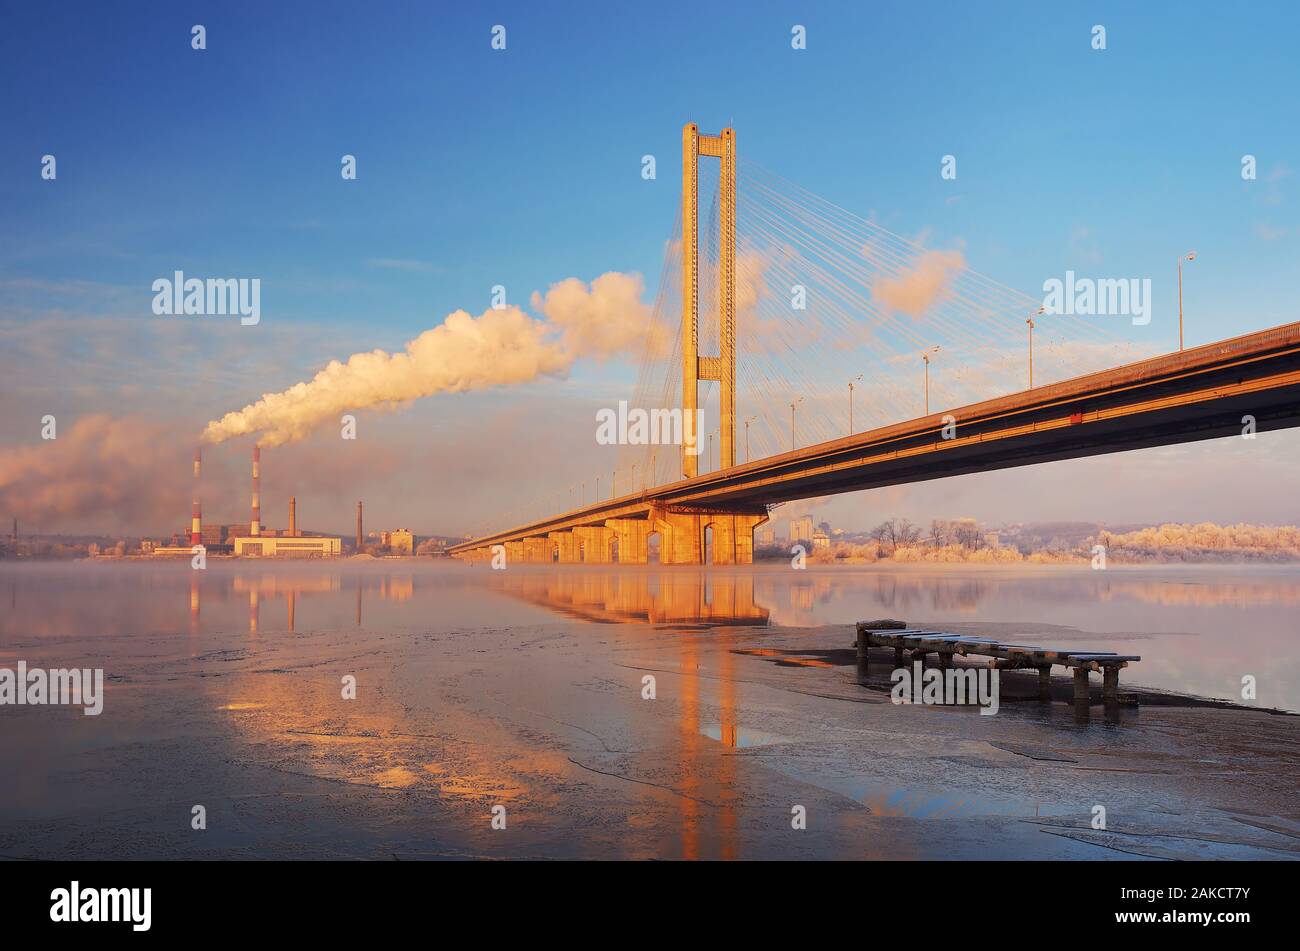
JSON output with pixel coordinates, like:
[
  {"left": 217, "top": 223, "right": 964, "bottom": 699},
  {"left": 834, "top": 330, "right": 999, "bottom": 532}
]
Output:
[{"left": 858, "top": 621, "right": 1141, "bottom": 704}]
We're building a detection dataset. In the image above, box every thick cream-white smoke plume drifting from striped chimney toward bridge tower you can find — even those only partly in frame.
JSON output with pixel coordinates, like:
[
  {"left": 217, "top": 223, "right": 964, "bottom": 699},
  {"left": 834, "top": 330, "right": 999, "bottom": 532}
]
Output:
[{"left": 203, "top": 272, "right": 666, "bottom": 446}]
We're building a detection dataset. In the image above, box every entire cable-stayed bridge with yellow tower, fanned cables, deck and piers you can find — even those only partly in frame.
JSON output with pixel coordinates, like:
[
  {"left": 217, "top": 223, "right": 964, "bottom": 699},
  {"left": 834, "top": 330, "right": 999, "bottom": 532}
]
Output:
[{"left": 452, "top": 125, "right": 1300, "bottom": 564}]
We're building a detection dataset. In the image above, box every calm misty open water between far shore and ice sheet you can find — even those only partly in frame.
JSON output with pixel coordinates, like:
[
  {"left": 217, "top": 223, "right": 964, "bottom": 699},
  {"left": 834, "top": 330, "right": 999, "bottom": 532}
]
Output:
[{"left": 0, "top": 560, "right": 1300, "bottom": 711}]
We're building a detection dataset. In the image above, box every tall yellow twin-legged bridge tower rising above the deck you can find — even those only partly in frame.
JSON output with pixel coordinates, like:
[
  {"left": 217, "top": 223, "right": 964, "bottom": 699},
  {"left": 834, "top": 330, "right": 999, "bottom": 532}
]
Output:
[{"left": 681, "top": 122, "right": 736, "bottom": 478}]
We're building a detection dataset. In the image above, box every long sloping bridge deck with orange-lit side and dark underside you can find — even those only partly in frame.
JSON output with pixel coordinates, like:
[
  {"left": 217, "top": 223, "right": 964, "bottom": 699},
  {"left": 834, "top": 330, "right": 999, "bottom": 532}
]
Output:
[{"left": 452, "top": 323, "right": 1300, "bottom": 552}]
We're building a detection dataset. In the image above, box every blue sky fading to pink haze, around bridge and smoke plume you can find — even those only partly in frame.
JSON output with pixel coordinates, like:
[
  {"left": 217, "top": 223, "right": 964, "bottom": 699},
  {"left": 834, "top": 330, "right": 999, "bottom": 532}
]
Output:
[{"left": 0, "top": 1, "right": 1300, "bottom": 534}]
